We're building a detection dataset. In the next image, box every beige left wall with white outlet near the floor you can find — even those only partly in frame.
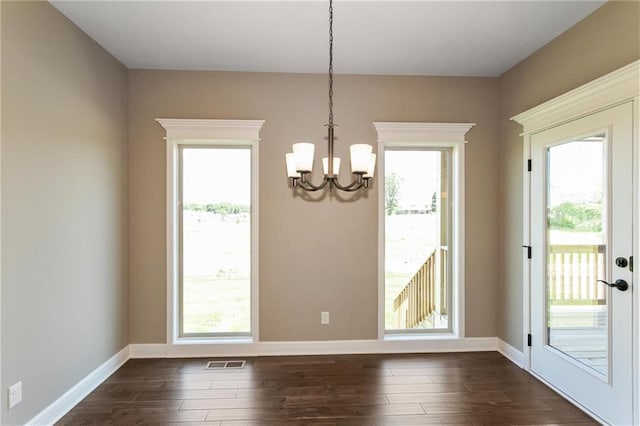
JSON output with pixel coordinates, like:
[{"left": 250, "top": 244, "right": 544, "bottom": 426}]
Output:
[{"left": 1, "top": 2, "right": 128, "bottom": 425}]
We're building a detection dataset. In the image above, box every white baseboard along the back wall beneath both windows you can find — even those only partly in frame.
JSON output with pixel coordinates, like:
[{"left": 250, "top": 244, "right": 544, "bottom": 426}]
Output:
[{"left": 129, "top": 337, "right": 498, "bottom": 358}]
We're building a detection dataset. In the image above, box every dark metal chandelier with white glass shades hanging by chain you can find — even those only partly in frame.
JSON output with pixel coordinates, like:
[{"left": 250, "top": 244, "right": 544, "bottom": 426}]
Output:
[{"left": 285, "top": 0, "right": 376, "bottom": 192}]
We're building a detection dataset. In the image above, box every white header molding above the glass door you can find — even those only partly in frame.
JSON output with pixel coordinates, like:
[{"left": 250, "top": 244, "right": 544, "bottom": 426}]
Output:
[{"left": 511, "top": 60, "right": 640, "bottom": 136}]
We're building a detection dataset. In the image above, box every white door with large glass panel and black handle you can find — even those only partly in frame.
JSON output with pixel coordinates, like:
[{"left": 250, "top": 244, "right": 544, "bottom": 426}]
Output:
[{"left": 530, "top": 102, "right": 634, "bottom": 424}]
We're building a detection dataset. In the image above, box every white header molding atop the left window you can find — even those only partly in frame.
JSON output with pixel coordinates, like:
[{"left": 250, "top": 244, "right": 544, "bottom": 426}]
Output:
[{"left": 156, "top": 118, "right": 264, "bottom": 141}]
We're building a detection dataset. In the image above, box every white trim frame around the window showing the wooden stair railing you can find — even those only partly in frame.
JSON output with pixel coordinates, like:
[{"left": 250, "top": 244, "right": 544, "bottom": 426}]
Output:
[{"left": 373, "top": 122, "right": 475, "bottom": 340}]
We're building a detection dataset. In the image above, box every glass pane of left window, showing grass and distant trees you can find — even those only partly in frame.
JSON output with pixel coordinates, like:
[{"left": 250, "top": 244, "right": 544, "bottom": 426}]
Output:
[{"left": 180, "top": 147, "right": 251, "bottom": 335}]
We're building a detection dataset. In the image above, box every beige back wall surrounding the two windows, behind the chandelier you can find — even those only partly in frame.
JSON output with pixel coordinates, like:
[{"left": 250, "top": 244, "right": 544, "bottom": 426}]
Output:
[{"left": 129, "top": 70, "right": 498, "bottom": 343}]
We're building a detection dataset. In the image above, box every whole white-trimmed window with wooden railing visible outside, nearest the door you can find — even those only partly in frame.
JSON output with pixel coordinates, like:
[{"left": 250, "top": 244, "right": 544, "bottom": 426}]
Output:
[{"left": 374, "top": 123, "right": 473, "bottom": 338}]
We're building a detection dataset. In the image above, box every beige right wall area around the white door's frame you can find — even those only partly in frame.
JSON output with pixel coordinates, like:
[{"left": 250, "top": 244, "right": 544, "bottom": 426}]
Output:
[{"left": 497, "top": 1, "right": 640, "bottom": 349}]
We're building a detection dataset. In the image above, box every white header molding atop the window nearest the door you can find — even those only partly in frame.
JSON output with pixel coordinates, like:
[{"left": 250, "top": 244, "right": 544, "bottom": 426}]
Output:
[{"left": 373, "top": 122, "right": 475, "bottom": 144}]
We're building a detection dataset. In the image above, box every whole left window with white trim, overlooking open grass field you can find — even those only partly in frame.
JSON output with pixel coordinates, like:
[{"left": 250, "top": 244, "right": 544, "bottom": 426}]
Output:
[{"left": 158, "top": 119, "right": 263, "bottom": 343}]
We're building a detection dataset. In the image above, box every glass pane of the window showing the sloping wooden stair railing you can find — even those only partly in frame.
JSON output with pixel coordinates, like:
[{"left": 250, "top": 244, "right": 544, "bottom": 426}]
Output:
[{"left": 384, "top": 149, "right": 450, "bottom": 331}]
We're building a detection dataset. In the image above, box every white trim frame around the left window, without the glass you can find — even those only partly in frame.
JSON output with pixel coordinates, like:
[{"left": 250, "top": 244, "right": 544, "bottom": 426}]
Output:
[{"left": 156, "top": 118, "right": 264, "bottom": 344}]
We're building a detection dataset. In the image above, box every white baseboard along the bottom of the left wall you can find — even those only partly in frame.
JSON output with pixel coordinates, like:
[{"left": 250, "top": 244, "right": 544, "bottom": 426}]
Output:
[{"left": 27, "top": 346, "right": 129, "bottom": 425}]
